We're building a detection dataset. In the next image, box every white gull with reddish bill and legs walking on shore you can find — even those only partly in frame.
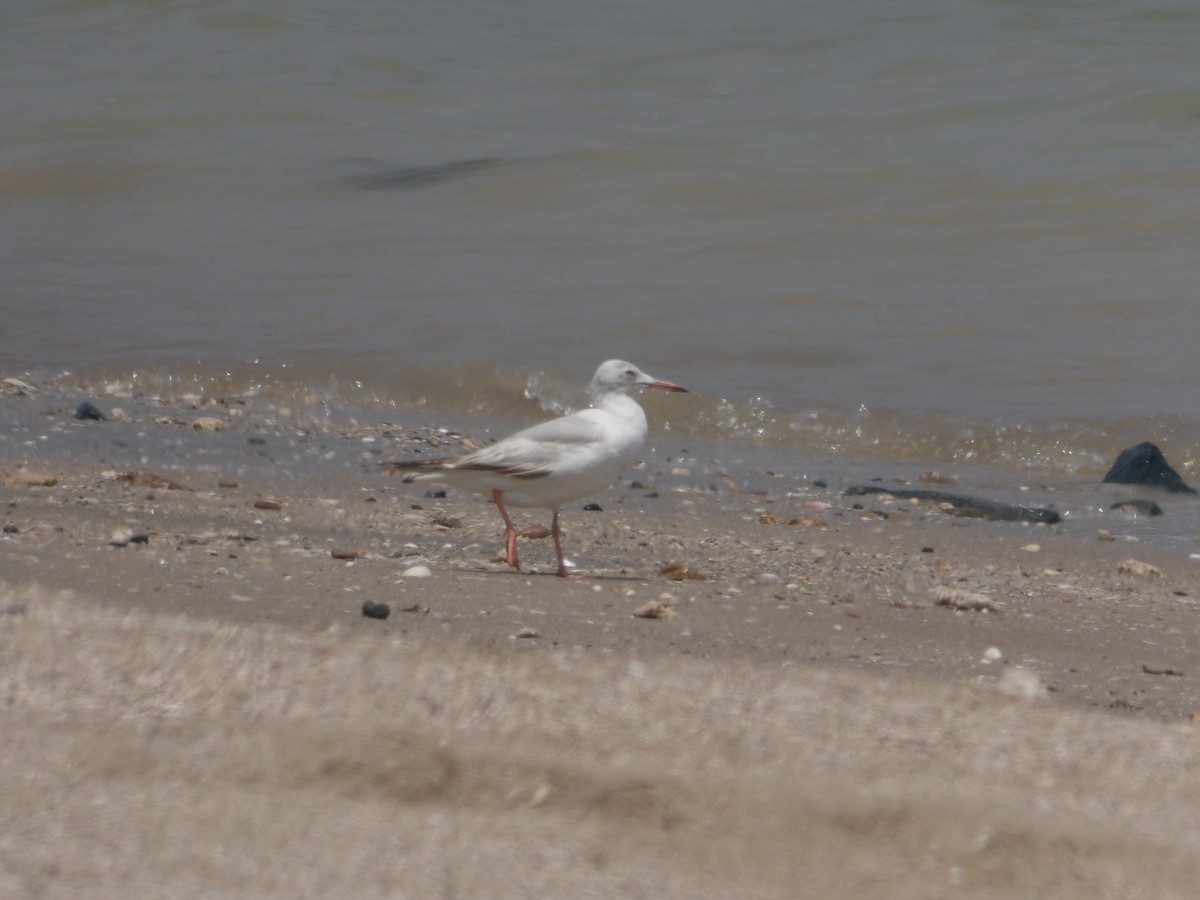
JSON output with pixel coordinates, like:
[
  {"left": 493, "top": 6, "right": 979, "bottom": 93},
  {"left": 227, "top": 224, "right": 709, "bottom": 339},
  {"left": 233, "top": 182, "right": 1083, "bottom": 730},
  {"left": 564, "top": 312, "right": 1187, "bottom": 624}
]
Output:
[{"left": 389, "top": 359, "right": 688, "bottom": 577}]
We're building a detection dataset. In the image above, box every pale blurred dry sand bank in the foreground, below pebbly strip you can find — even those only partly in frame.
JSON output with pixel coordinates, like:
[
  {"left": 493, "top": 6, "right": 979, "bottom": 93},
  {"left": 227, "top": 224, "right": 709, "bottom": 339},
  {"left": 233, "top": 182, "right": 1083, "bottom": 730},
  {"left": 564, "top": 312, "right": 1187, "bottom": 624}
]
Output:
[{"left": 7, "top": 580, "right": 1200, "bottom": 898}]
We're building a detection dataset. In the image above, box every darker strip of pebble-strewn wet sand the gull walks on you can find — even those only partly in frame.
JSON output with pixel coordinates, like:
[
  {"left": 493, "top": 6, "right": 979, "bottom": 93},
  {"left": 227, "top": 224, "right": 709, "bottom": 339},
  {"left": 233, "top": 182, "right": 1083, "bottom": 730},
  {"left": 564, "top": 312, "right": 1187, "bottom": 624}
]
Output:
[{"left": 0, "top": 376, "right": 1200, "bottom": 720}]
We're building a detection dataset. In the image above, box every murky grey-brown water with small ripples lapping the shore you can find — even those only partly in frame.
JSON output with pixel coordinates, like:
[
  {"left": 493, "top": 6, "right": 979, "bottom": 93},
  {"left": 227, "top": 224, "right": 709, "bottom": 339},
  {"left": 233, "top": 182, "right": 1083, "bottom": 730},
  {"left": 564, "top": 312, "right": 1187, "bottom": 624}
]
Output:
[{"left": 0, "top": 0, "right": 1200, "bottom": 478}]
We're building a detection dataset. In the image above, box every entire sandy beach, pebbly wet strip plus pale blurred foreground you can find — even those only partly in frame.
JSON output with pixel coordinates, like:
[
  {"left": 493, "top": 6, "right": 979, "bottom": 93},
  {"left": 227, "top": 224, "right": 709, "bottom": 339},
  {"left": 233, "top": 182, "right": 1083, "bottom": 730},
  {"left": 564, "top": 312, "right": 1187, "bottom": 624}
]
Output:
[{"left": 0, "top": 385, "right": 1200, "bottom": 898}]
